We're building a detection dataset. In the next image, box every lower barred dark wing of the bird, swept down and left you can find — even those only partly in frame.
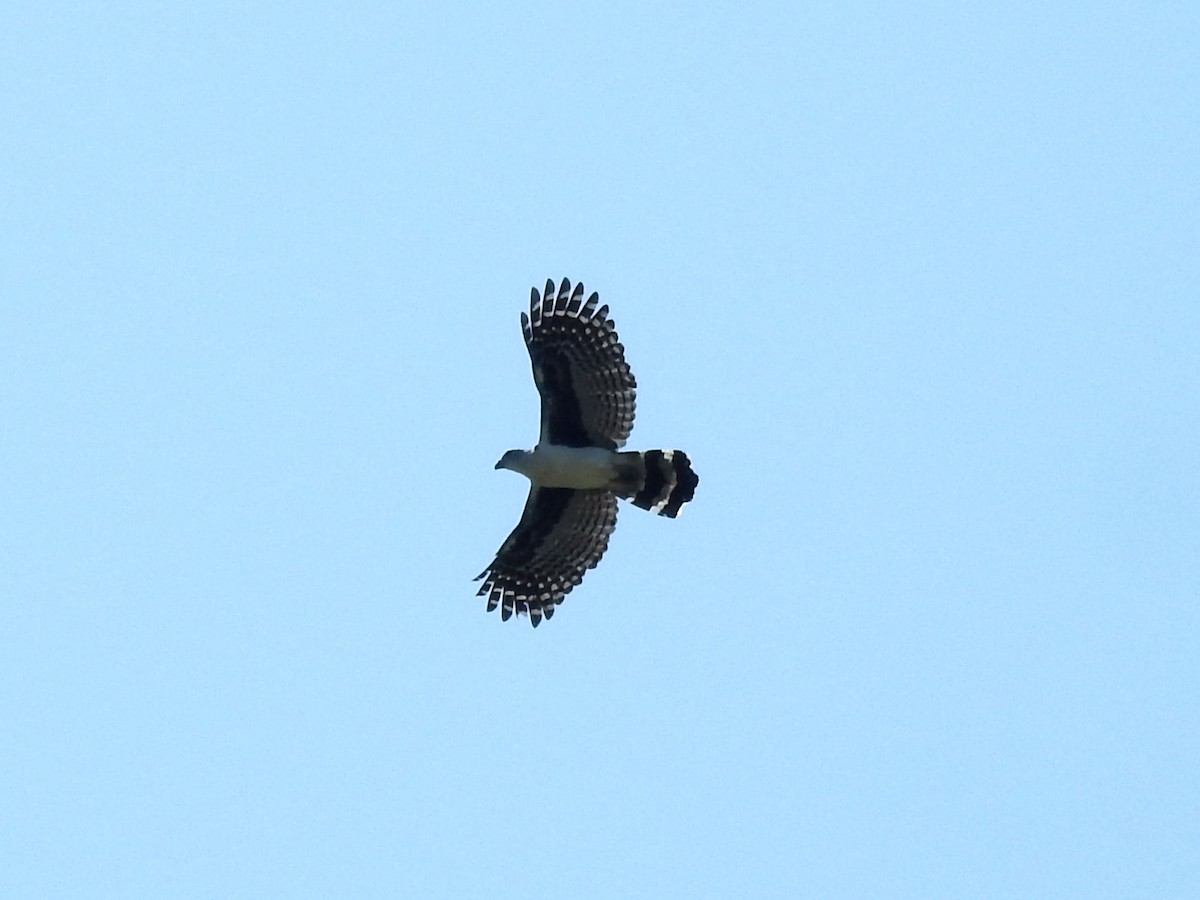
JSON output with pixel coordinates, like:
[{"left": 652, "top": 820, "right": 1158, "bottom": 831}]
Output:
[{"left": 476, "top": 486, "right": 617, "bottom": 626}]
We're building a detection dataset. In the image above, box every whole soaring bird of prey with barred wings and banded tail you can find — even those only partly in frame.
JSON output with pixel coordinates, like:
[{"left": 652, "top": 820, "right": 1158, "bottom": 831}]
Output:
[{"left": 475, "top": 278, "right": 700, "bottom": 626}]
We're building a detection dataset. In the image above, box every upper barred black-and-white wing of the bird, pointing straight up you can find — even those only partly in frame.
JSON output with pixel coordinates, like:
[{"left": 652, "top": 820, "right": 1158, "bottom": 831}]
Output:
[{"left": 521, "top": 278, "right": 637, "bottom": 450}]
